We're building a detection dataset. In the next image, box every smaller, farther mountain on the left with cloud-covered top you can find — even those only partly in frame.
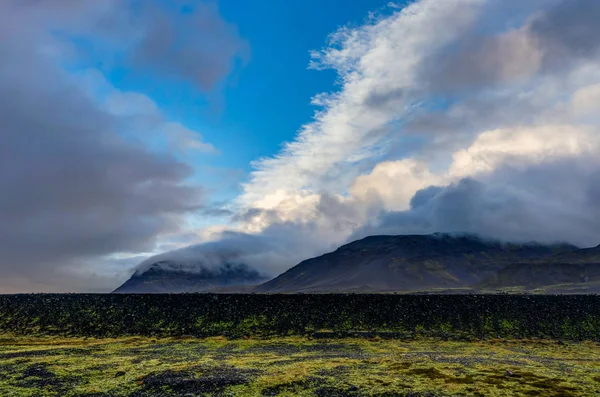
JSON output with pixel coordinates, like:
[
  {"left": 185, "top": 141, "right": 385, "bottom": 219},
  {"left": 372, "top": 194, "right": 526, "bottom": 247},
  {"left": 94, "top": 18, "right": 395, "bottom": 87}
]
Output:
[{"left": 113, "top": 261, "right": 266, "bottom": 293}]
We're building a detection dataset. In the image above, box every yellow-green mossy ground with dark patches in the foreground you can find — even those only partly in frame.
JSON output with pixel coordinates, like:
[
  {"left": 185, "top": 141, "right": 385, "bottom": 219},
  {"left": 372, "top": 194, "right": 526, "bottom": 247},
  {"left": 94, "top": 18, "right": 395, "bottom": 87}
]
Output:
[{"left": 0, "top": 334, "right": 600, "bottom": 397}]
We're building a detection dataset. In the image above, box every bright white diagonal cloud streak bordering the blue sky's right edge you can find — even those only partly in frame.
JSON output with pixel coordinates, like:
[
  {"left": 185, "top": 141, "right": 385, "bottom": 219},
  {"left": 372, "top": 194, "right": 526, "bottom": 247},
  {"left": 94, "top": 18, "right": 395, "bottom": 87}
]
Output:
[{"left": 240, "top": 0, "right": 483, "bottom": 206}]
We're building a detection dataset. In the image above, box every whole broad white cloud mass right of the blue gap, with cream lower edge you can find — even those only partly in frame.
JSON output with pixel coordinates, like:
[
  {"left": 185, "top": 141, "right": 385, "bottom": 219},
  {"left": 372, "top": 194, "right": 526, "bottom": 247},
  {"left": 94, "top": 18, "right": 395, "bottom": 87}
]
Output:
[{"left": 232, "top": 0, "right": 597, "bottom": 232}]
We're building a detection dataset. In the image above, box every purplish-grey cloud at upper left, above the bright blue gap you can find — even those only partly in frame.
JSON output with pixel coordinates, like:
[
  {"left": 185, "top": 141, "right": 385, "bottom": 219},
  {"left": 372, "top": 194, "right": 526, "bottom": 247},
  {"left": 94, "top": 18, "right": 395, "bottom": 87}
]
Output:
[{"left": 18, "top": 0, "right": 250, "bottom": 91}]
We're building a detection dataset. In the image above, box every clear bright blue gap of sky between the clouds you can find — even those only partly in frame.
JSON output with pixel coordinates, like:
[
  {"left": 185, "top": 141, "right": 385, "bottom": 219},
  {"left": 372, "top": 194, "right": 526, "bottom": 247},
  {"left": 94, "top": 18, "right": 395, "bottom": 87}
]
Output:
[{"left": 96, "top": 0, "right": 388, "bottom": 201}]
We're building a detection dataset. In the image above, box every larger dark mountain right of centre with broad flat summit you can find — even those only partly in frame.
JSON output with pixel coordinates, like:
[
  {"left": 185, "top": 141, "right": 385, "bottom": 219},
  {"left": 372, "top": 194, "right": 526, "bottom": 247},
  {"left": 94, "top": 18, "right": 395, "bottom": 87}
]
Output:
[{"left": 254, "top": 234, "right": 576, "bottom": 292}]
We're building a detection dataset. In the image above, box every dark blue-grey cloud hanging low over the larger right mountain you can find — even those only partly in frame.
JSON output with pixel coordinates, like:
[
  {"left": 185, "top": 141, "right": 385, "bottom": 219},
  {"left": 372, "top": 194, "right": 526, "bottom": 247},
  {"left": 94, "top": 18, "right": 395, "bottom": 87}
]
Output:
[{"left": 350, "top": 158, "right": 600, "bottom": 246}]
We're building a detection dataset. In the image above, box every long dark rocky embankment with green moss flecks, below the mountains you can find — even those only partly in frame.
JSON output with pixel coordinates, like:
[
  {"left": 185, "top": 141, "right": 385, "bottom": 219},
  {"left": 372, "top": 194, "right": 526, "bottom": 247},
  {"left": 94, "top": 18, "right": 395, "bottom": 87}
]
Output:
[{"left": 0, "top": 294, "right": 600, "bottom": 340}]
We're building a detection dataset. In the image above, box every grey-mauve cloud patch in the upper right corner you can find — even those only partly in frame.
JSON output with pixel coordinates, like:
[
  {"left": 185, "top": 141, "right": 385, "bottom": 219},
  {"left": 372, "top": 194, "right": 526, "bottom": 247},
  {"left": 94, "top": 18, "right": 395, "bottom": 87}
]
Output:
[{"left": 419, "top": 0, "right": 600, "bottom": 95}]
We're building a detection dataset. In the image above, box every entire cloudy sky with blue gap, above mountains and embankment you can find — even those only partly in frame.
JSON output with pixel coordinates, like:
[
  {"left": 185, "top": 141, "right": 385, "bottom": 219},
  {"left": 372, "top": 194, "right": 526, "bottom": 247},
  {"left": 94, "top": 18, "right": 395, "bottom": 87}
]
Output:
[{"left": 0, "top": 0, "right": 600, "bottom": 293}]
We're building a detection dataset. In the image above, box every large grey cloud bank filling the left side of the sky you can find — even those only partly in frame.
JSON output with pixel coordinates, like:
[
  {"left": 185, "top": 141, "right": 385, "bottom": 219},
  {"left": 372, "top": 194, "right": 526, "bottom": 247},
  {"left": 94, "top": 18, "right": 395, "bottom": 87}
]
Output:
[{"left": 0, "top": 0, "right": 247, "bottom": 292}]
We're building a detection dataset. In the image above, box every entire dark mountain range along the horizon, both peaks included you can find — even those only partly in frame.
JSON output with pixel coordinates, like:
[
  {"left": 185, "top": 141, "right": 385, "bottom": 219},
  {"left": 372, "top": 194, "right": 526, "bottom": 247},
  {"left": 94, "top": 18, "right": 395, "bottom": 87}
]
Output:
[{"left": 114, "top": 233, "right": 600, "bottom": 293}]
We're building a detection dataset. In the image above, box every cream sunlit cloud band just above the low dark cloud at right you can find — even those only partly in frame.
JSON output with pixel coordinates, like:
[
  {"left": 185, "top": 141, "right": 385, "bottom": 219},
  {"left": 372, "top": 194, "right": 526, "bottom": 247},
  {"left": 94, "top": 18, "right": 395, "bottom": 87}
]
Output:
[{"left": 350, "top": 121, "right": 600, "bottom": 220}]
